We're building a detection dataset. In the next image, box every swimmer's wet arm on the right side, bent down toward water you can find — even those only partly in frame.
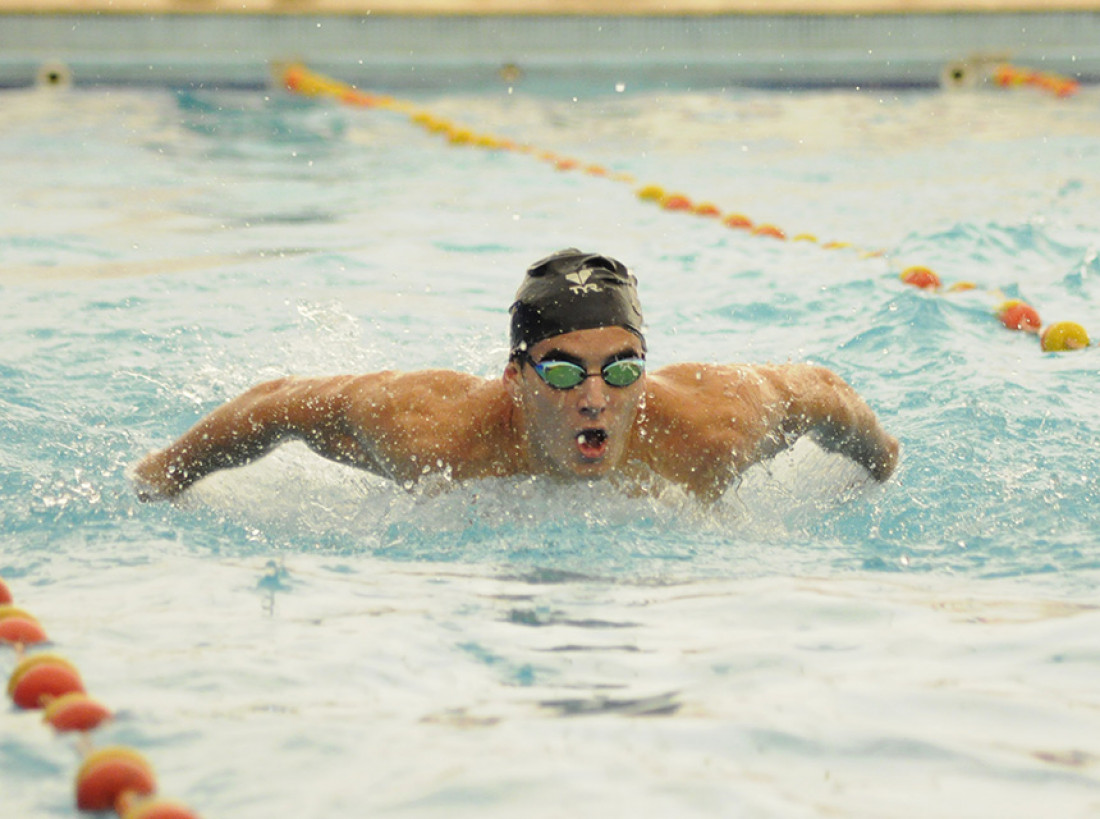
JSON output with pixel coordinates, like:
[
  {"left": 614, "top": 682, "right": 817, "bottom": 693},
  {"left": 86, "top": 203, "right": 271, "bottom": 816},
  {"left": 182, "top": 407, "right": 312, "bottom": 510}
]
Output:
[{"left": 782, "top": 364, "right": 899, "bottom": 480}]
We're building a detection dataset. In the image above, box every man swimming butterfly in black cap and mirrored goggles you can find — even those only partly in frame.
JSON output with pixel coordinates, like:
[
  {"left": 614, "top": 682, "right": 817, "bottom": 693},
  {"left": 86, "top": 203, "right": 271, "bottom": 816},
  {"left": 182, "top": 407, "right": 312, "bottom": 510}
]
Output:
[{"left": 134, "top": 248, "right": 899, "bottom": 501}]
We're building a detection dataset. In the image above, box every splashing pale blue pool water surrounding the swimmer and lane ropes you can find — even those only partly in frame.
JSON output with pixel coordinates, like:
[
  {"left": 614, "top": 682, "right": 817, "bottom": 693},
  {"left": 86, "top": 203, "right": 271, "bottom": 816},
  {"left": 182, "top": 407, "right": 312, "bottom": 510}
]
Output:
[{"left": 0, "top": 78, "right": 1100, "bottom": 819}]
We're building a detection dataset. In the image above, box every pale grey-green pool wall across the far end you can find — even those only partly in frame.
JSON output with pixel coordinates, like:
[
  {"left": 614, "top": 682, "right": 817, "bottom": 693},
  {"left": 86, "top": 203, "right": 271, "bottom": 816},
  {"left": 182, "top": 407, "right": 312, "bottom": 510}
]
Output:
[{"left": 0, "top": 2, "right": 1100, "bottom": 91}]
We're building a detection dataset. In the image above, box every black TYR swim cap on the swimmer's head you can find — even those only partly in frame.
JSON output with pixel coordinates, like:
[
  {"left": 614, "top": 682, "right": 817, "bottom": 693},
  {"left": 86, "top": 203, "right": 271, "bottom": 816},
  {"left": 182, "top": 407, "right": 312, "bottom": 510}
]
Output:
[{"left": 510, "top": 247, "right": 646, "bottom": 355}]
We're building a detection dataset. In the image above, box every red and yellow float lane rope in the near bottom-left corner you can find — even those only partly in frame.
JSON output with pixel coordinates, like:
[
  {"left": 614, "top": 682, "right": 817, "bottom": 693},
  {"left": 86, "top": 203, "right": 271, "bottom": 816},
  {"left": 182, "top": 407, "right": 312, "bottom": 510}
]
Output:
[{"left": 0, "top": 577, "right": 199, "bottom": 819}]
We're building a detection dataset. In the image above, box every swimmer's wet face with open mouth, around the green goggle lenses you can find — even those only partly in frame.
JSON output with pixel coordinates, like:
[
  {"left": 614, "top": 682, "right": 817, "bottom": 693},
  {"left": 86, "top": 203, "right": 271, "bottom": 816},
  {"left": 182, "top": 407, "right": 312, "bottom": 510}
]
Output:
[{"left": 504, "top": 327, "right": 646, "bottom": 478}]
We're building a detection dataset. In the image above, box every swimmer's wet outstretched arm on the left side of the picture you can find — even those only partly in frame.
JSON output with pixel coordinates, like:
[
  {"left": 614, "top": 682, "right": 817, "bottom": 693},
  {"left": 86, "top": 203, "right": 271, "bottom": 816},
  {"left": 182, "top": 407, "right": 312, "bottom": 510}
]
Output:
[{"left": 134, "top": 376, "right": 385, "bottom": 500}]
